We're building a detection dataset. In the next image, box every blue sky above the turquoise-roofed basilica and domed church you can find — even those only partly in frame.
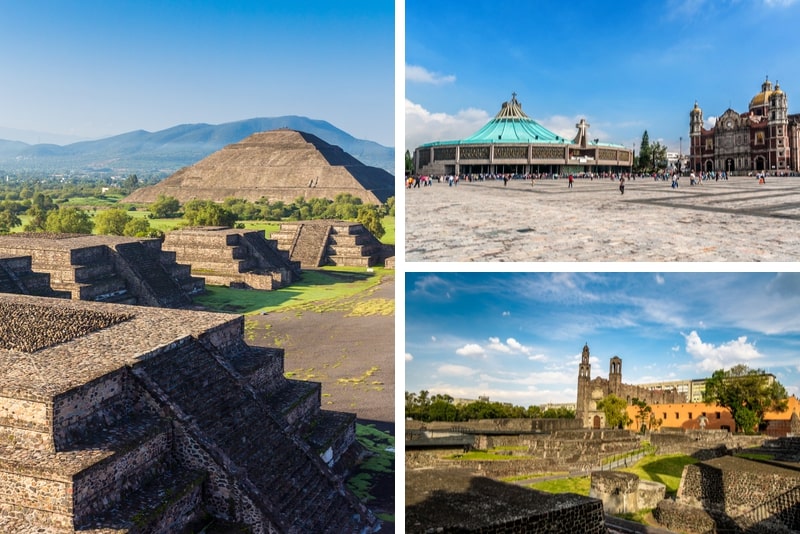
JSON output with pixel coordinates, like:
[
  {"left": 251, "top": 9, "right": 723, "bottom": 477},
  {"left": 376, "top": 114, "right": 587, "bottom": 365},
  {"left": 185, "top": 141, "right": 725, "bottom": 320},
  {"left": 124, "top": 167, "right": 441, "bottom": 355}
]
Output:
[{"left": 405, "top": 0, "right": 800, "bottom": 153}]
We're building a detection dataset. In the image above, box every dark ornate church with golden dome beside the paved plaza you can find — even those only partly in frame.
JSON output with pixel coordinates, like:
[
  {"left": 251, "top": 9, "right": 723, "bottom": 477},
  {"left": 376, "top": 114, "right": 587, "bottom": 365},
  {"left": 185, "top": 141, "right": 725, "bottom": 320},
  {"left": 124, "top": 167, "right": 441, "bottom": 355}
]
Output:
[{"left": 689, "top": 78, "right": 800, "bottom": 175}]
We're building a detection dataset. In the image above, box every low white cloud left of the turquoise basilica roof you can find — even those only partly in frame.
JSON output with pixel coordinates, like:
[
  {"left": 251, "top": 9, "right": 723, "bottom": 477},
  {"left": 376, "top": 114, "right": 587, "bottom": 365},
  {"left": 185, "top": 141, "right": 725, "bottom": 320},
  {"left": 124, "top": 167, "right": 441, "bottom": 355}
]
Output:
[{"left": 406, "top": 99, "right": 491, "bottom": 151}]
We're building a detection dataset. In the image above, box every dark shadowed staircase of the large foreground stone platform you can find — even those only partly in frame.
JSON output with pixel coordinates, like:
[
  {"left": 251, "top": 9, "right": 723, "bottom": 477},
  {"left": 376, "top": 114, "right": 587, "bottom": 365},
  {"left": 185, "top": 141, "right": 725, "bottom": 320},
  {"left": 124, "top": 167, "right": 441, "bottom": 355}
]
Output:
[{"left": 134, "top": 343, "right": 373, "bottom": 532}]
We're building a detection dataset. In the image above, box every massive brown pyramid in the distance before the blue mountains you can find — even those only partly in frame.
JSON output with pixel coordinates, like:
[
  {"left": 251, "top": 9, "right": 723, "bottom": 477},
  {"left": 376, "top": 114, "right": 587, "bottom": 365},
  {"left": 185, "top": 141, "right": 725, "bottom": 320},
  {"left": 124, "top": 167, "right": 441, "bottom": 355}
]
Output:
[{"left": 124, "top": 129, "right": 394, "bottom": 204}]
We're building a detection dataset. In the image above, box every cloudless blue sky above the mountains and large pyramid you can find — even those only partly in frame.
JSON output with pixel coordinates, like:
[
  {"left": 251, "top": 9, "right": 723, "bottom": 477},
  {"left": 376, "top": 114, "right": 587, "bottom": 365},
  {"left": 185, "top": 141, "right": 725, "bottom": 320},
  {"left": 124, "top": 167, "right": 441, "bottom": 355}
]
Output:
[{"left": 0, "top": 0, "right": 395, "bottom": 146}]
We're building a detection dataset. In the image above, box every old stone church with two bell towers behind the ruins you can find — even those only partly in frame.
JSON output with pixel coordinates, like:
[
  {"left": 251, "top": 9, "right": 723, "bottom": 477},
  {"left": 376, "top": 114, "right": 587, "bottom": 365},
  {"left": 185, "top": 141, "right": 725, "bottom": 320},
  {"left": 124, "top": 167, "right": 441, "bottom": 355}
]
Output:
[{"left": 575, "top": 344, "right": 686, "bottom": 428}]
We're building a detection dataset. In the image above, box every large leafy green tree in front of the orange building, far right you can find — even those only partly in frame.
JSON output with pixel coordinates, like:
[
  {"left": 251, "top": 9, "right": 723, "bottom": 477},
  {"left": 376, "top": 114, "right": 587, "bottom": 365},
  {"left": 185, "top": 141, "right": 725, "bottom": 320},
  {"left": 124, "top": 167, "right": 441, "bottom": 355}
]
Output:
[{"left": 703, "top": 364, "right": 788, "bottom": 433}]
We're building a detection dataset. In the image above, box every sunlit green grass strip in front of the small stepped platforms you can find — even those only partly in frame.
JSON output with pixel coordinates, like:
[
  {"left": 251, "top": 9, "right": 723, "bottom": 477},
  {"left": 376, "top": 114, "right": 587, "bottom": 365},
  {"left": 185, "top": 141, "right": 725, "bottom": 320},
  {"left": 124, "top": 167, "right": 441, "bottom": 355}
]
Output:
[{"left": 194, "top": 267, "right": 394, "bottom": 314}]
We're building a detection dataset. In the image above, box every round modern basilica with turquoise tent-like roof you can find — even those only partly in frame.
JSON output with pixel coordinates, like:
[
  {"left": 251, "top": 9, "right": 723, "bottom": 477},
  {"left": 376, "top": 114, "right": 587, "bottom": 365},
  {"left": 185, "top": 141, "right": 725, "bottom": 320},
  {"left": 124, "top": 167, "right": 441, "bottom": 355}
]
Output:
[{"left": 414, "top": 93, "right": 633, "bottom": 176}]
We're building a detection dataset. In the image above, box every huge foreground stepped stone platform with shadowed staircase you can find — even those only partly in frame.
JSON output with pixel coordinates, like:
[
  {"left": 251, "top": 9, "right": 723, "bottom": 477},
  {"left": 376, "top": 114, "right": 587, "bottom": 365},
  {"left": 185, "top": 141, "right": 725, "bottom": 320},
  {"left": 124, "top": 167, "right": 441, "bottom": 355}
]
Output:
[{"left": 0, "top": 294, "right": 378, "bottom": 533}]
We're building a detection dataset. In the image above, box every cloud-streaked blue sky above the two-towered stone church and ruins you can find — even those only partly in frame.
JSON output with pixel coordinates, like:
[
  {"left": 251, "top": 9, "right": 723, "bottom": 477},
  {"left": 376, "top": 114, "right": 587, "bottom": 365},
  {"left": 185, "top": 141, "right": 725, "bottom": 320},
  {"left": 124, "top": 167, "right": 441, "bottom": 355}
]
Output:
[{"left": 405, "top": 272, "right": 800, "bottom": 406}]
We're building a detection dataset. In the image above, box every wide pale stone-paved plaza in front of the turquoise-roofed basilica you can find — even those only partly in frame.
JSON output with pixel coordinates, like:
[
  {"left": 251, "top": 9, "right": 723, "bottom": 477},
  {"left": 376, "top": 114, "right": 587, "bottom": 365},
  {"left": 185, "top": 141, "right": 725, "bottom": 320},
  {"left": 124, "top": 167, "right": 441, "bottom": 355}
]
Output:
[{"left": 405, "top": 176, "right": 800, "bottom": 262}]
